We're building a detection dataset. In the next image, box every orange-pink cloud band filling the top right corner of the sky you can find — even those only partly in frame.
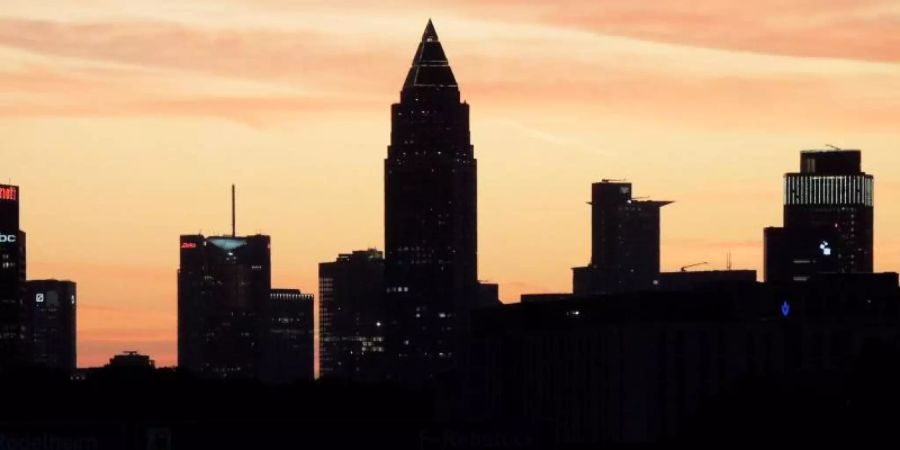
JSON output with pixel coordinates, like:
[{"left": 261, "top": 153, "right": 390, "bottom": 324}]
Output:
[{"left": 450, "top": 0, "right": 900, "bottom": 62}]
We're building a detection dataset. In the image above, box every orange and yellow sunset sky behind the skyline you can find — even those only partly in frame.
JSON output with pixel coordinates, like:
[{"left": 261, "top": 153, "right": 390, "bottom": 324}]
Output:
[{"left": 0, "top": 0, "right": 900, "bottom": 366}]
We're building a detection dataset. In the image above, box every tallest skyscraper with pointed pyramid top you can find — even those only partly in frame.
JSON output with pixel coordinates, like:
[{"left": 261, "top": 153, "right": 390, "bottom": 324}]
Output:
[{"left": 384, "top": 21, "right": 478, "bottom": 383}]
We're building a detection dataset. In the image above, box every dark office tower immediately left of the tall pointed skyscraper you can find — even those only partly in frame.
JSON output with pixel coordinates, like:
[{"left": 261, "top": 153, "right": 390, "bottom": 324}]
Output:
[{"left": 319, "top": 249, "right": 385, "bottom": 381}]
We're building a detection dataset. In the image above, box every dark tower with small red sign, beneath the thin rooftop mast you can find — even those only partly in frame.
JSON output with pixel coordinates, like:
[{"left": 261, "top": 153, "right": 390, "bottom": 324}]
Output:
[{"left": 178, "top": 235, "right": 272, "bottom": 378}]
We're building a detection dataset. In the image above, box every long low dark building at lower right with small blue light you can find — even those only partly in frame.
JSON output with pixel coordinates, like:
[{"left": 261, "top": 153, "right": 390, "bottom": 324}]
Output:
[{"left": 470, "top": 273, "right": 900, "bottom": 448}]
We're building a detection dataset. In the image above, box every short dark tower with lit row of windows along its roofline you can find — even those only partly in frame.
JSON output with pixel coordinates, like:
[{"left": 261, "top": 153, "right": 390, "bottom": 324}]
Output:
[{"left": 261, "top": 289, "right": 315, "bottom": 384}]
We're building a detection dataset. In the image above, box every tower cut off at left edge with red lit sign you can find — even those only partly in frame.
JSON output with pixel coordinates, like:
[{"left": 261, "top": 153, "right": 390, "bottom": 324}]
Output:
[{"left": 0, "top": 184, "right": 28, "bottom": 372}]
